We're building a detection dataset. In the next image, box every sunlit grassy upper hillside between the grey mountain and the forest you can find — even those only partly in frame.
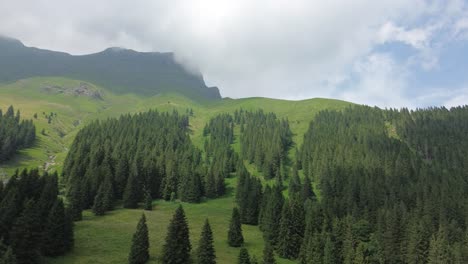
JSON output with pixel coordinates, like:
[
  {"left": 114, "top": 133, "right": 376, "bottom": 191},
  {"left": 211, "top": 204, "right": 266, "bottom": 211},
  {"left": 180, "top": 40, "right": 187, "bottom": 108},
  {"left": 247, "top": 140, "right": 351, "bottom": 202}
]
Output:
[{"left": 0, "top": 77, "right": 349, "bottom": 175}]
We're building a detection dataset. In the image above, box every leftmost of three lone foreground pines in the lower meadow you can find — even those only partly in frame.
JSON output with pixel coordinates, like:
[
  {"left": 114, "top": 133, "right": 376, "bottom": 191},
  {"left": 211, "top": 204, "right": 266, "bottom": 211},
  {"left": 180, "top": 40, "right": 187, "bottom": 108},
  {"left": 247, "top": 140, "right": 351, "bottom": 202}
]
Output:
[{"left": 128, "top": 214, "right": 149, "bottom": 264}]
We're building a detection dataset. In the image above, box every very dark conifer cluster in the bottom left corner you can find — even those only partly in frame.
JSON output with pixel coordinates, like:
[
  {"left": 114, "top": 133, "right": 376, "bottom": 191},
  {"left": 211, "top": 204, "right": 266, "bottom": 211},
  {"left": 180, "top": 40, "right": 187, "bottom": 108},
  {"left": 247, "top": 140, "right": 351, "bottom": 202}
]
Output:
[{"left": 0, "top": 170, "right": 74, "bottom": 264}]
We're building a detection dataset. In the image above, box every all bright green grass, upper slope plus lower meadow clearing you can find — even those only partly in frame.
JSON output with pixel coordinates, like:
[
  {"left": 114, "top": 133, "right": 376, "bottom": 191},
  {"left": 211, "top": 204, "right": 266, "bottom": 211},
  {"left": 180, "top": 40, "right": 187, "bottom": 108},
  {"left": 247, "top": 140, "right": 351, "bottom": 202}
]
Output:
[{"left": 0, "top": 78, "right": 349, "bottom": 264}]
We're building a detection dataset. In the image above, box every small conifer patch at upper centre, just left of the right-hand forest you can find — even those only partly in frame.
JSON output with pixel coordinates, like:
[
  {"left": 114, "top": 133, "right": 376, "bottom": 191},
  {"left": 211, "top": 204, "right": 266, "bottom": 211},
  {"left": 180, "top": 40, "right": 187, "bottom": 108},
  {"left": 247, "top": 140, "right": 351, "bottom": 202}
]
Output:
[{"left": 234, "top": 109, "right": 293, "bottom": 179}]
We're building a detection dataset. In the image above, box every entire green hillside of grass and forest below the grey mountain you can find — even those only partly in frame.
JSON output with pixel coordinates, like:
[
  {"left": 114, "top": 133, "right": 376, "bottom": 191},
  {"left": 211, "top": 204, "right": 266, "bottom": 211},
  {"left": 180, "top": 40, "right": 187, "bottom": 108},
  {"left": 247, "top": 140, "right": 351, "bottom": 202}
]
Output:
[{"left": 0, "top": 75, "right": 468, "bottom": 264}]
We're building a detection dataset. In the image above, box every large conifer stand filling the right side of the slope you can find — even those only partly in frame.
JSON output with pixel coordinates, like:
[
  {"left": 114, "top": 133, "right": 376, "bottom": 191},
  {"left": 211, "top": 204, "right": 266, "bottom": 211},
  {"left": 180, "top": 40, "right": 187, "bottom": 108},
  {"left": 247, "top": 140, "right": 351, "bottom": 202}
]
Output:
[{"left": 294, "top": 106, "right": 468, "bottom": 263}]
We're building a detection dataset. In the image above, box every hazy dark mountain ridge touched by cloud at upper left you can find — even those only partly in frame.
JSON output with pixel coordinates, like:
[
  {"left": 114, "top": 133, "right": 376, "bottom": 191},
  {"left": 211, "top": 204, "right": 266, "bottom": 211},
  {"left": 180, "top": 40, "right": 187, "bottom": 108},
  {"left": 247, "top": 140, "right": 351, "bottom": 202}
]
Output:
[{"left": 0, "top": 36, "right": 221, "bottom": 99}]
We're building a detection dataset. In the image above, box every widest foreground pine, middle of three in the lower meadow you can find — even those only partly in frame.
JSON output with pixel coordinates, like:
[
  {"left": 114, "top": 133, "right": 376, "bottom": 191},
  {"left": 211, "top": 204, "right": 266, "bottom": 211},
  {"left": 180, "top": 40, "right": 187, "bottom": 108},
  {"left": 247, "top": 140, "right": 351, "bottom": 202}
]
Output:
[{"left": 162, "top": 206, "right": 192, "bottom": 264}]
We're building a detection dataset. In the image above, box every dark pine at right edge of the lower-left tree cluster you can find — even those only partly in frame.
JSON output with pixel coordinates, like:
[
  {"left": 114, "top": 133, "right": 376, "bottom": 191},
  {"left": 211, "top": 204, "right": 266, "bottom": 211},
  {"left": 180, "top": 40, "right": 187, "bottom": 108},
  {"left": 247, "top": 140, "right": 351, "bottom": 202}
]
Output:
[{"left": 42, "top": 198, "right": 67, "bottom": 256}]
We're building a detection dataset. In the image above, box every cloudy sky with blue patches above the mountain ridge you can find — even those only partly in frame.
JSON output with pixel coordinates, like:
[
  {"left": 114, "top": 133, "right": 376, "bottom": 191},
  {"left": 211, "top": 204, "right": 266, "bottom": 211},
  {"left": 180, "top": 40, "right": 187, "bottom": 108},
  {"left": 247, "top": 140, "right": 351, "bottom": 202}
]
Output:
[{"left": 0, "top": 0, "right": 468, "bottom": 108}]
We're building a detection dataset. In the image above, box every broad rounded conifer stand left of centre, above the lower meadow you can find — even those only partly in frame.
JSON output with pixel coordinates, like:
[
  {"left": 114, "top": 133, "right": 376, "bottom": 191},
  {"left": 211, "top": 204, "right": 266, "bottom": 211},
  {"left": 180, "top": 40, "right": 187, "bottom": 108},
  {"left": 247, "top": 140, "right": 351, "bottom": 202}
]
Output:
[{"left": 63, "top": 111, "right": 210, "bottom": 220}]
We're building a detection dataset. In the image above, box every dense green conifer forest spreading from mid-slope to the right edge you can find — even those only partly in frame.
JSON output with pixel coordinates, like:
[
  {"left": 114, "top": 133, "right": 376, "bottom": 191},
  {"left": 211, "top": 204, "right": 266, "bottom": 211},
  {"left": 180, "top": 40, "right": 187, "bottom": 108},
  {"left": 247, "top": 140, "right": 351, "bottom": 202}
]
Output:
[{"left": 28, "top": 106, "right": 468, "bottom": 263}]
